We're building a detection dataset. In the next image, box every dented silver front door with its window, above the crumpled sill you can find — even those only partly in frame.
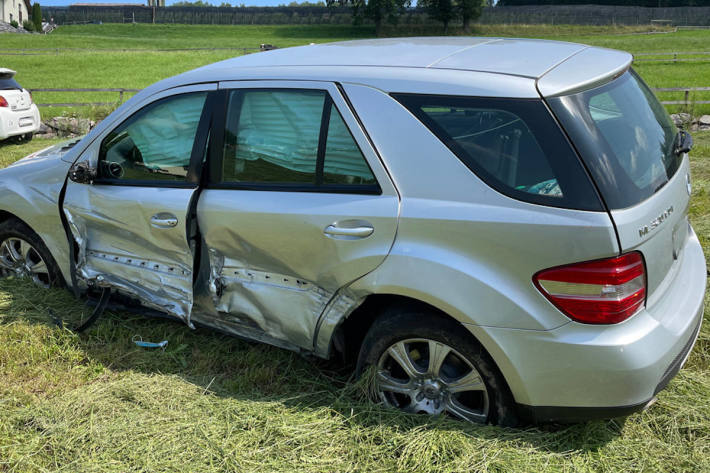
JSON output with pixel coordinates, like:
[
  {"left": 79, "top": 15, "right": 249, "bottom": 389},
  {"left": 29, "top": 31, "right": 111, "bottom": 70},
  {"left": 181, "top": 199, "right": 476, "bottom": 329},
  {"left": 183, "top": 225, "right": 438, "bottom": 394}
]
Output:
[{"left": 63, "top": 85, "right": 215, "bottom": 324}]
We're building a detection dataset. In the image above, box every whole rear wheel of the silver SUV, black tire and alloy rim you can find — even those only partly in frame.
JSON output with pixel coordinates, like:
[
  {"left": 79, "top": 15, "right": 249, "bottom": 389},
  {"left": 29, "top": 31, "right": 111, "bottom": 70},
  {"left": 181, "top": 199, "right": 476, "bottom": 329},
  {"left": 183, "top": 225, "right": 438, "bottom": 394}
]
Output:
[{"left": 356, "top": 307, "right": 517, "bottom": 426}]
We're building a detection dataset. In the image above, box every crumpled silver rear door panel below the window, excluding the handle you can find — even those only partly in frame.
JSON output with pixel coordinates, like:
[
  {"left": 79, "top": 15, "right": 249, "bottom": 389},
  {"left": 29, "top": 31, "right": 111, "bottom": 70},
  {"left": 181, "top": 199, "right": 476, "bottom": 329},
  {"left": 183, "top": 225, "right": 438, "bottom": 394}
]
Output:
[{"left": 194, "top": 189, "right": 399, "bottom": 351}]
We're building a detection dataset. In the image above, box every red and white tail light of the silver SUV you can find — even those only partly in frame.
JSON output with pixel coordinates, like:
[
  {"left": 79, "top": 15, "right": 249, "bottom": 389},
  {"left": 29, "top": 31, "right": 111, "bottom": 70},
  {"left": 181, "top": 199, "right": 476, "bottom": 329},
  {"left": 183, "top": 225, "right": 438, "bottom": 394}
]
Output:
[{"left": 533, "top": 251, "right": 646, "bottom": 324}]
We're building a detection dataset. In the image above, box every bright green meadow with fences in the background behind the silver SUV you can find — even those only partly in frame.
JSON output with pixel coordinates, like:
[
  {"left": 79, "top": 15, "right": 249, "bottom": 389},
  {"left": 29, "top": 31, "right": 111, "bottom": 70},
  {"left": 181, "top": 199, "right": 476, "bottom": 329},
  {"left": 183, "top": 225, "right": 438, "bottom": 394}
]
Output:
[{"left": 0, "top": 24, "right": 710, "bottom": 118}]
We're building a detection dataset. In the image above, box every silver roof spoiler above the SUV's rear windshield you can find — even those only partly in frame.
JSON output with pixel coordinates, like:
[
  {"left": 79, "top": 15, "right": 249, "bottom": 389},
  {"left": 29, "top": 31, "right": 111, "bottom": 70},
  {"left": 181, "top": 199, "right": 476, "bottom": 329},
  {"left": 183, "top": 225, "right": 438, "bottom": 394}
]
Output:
[{"left": 537, "top": 47, "right": 634, "bottom": 97}]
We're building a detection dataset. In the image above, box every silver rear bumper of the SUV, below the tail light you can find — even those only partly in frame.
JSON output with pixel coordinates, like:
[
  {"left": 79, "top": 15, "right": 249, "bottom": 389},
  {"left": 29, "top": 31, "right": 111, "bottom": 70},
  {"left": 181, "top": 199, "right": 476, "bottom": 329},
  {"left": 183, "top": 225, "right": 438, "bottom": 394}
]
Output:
[{"left": 468, "top": 225, "right": 707, "bottom": 422}]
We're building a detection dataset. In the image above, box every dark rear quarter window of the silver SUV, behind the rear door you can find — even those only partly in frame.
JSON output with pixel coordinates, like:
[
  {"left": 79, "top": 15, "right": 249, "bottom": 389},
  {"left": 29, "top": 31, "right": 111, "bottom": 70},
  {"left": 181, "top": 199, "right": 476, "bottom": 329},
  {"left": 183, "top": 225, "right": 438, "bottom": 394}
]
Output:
[{"left": 395, "top": 94, "right": 603, "bottom": 210}]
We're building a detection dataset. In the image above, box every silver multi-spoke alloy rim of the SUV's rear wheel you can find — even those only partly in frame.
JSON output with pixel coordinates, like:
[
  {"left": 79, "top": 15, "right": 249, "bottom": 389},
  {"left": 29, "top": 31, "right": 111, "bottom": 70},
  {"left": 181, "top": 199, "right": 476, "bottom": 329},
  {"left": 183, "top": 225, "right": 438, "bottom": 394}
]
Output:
[{"left": 375, "top": 338, "right": 489, "bottom": 423}]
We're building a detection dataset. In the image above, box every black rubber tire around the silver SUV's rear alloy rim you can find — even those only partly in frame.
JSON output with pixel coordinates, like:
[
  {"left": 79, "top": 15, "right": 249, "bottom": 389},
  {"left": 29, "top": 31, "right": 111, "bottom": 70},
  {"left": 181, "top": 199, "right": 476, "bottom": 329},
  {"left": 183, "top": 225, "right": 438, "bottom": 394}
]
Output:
[{"left": 356, "top": 309, "right": 517, "bottom": 426}]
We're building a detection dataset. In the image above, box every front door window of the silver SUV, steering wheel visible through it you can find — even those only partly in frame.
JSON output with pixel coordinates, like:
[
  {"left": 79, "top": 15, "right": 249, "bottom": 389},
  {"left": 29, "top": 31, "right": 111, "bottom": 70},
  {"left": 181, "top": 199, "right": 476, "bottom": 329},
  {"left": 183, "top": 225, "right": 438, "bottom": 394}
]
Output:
[{"left": 99, "top": 92, "right": 207, "bottom": 182}]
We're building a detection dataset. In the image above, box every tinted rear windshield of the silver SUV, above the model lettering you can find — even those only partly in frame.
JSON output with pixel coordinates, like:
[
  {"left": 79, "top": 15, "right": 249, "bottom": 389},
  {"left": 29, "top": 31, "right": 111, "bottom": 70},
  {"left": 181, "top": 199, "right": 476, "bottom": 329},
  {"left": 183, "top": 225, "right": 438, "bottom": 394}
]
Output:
[{"left": 549, "top": 72, "right": 682, "bottom": 209}]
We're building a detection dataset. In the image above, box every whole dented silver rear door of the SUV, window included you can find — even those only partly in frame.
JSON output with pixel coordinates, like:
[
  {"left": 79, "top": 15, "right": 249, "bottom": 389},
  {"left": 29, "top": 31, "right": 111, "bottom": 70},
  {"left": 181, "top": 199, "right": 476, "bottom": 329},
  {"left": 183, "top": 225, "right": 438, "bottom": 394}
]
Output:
[{"left": 195, "top": 81, "right": 399, "bottom": 349}]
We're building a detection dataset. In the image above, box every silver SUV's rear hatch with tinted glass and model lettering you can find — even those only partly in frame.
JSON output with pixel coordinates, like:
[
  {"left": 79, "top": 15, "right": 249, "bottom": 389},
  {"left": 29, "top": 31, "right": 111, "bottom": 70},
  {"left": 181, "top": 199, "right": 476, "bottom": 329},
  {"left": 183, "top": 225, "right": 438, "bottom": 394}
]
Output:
[{"left": 547, "top": 70, "right": 690, "bottom": 305}]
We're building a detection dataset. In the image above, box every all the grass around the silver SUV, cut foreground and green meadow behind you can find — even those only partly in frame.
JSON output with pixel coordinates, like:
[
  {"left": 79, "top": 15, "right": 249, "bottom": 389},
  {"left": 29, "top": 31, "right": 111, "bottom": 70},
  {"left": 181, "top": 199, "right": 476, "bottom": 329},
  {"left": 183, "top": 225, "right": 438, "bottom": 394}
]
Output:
[{"left": 0, "top": 25, "right": 710, "bottom": 473}]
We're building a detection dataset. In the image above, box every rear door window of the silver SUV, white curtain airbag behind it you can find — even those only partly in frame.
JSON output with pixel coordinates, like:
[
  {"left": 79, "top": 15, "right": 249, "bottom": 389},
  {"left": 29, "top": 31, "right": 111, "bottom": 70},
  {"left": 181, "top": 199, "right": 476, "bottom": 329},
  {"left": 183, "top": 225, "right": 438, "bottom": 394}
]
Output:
[{"left": 220, "top": 89, "right": 377, "bottom": 191}]
